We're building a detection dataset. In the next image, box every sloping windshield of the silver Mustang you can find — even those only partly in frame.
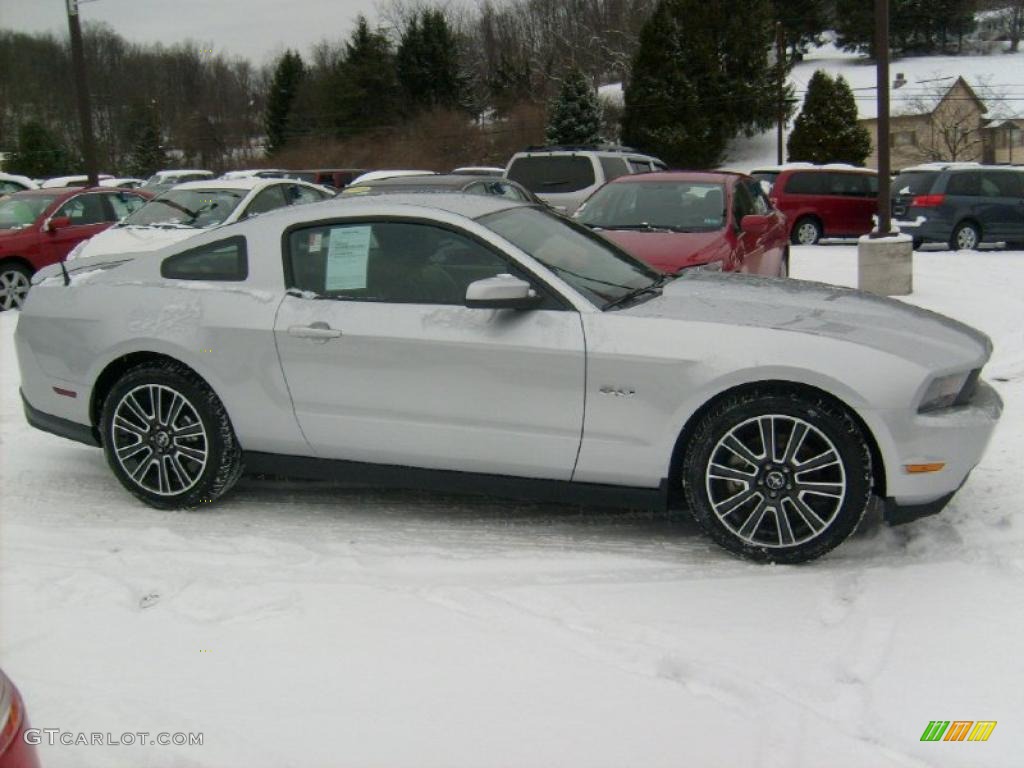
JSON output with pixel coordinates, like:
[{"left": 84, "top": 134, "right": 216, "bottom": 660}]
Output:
[{"left": 479, "top": 208, "right": 663, "bottom": 307}]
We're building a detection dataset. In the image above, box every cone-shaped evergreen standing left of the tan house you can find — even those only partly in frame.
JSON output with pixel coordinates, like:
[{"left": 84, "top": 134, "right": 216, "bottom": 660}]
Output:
[{"left": 786, "top": 70, "right": 871, "bottom": 165}]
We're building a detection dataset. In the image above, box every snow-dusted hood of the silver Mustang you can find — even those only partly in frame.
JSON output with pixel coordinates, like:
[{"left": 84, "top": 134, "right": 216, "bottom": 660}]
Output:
[{"left": 623, "top": 271, "right": 992, "bottom": 370}]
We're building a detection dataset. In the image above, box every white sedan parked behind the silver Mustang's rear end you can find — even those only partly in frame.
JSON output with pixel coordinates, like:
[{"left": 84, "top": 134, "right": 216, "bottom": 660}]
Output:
[{"left": 67, "top": 178, "right": 334, "bottom": 261}]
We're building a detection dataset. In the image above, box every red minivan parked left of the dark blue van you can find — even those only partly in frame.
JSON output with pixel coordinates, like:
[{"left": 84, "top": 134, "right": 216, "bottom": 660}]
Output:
[{"left": 768, "top": 165, "right": 879, "bottom": 246}]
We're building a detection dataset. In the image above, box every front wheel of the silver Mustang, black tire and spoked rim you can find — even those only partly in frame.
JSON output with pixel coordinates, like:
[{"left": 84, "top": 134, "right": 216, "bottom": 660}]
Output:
[{"left": 682, "top": 388, "right": 871, "bottom": 563}]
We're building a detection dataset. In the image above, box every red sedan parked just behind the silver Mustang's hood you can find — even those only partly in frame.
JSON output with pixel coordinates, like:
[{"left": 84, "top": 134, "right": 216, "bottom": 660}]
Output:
[{"left": 574, "top": 171, "right": 790, "bottom": 276}]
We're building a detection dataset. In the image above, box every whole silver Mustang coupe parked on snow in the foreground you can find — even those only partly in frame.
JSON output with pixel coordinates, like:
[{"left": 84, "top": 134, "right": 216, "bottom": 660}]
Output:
[{"left": 15, "top": 195, "right": 1001, "bottom": 562}]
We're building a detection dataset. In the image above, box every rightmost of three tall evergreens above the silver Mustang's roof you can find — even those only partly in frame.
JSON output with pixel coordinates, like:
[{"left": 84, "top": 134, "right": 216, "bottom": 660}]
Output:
[{"left": 395, "top": 8, "right": 466, "bottom": 109}]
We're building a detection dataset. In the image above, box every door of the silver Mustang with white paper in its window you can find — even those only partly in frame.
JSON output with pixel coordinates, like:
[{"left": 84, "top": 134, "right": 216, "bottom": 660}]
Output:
[{"left": 274, "top": 219, "right": 585, "bottom": 480}]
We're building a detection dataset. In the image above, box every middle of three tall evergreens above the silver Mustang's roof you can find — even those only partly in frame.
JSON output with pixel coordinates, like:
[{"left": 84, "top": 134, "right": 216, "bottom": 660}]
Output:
[{"left": 332, "top": 15, "right": 401, "bottom": 137}]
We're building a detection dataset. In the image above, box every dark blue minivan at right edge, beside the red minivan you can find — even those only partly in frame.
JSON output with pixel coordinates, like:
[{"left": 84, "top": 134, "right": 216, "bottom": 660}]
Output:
[{"left": 892, "top": 163, "right": 1024, "bottom": 250}]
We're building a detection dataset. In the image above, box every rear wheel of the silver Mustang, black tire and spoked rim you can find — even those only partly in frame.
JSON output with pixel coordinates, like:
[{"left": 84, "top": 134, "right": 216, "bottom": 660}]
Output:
[{"left": 100, "top": 361, "right": 243, "bottom": 509}]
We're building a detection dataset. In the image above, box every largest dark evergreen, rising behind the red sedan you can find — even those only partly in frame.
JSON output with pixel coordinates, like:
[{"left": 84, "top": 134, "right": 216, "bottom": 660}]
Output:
[{"left": 623, "top": 0, "right": 777, "bottom": 168}]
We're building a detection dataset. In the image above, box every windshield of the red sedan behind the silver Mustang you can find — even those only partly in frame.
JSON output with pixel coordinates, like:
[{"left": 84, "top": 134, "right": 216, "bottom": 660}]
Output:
[{"left": 577, "top": 181, "right": 725, "bottom": 231}]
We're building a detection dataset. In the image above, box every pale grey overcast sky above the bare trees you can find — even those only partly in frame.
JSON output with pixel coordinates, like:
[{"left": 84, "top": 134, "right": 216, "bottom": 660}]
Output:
[{"left": 0, "top": 0, "right": 375, "bottom": 65}]
